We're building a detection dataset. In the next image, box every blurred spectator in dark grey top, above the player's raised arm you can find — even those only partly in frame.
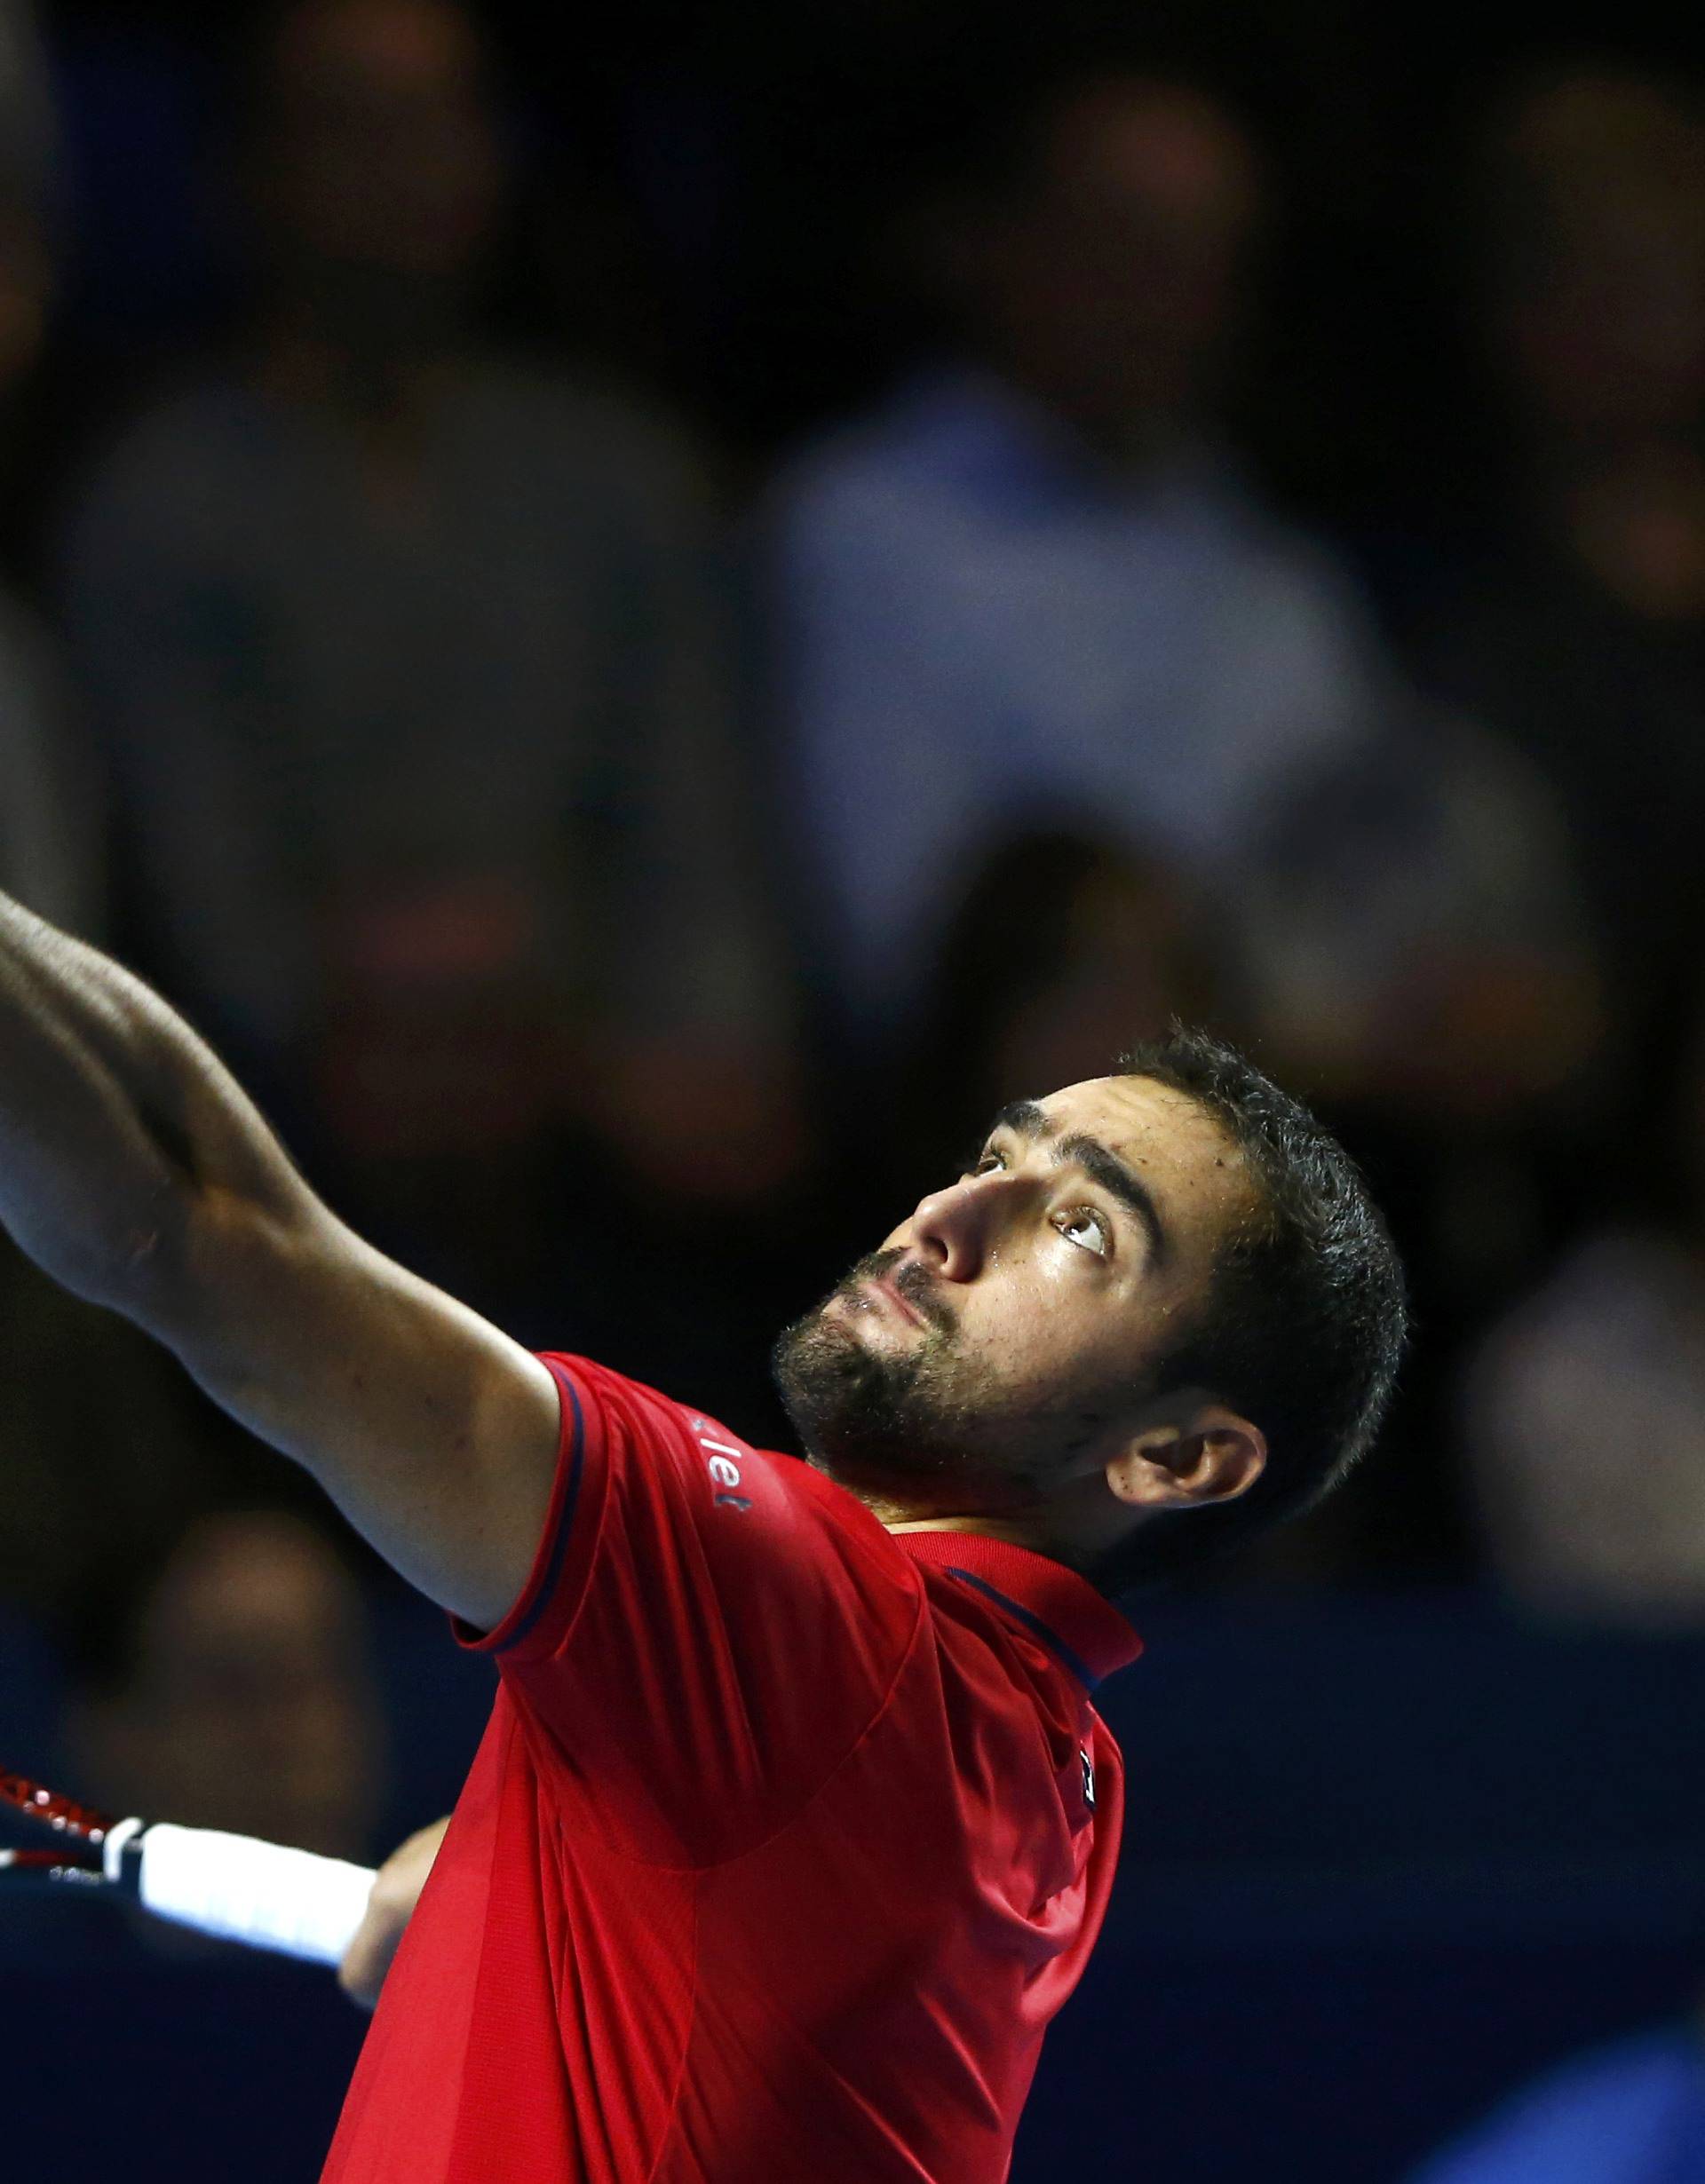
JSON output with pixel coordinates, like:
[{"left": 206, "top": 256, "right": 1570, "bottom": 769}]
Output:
[{"left": 67, "top": 0, "right": 794, "bottom": 1309}]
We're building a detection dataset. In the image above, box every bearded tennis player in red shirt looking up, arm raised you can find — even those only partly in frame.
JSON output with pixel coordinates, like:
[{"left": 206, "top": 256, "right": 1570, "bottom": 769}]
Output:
[{"left": 0, "top": 898, "right": 1403, "bottom": 2184}]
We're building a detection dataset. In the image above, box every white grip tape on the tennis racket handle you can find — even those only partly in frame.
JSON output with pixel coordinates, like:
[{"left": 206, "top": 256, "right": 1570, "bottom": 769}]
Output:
[{"left": 140, "top": 1822, "right": 374, "bottom": 1964}]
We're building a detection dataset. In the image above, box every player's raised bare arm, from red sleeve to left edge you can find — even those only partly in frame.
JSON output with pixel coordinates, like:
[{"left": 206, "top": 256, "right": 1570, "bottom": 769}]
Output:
[{"left": 0, "top": 896, "right": 558, "bottom": 1627}]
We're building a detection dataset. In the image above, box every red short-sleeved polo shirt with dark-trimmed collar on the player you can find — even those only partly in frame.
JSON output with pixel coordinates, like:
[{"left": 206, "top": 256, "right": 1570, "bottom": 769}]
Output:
[{"left": 326, "top": 1357, "right": 1138, "bottom": 2184}]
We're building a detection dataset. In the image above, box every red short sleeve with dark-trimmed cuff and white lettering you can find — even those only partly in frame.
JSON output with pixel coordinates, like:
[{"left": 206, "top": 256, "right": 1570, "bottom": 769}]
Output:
[{"left": 459, "top": 1354, "right": 924, "bottom": 1863}]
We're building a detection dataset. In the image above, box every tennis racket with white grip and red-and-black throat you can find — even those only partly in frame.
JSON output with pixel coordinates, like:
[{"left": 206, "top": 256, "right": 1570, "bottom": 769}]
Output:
[{"left": 0, "top": 1769, "right": 374, "bottom": 1964}]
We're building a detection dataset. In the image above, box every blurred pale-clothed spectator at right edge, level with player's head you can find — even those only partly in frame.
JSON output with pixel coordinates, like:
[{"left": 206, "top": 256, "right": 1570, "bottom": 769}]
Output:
[{"left": 1463, "top": 974, "right": 1705, "bottom": 1623}]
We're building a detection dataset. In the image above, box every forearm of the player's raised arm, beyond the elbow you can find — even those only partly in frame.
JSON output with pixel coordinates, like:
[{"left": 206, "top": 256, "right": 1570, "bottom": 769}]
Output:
[{"left": 0, "top": 896, "right": 290, "bottom": 1312}]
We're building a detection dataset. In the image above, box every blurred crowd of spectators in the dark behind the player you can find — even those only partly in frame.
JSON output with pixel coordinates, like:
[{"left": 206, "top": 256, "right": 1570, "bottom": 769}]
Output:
[{"left": 0, "top": 0, "right": 1705, "bottom": 1848}]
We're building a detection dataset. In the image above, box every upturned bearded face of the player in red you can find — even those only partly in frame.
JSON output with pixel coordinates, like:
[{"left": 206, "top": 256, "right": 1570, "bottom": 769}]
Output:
[{"left": 773, "top": 1077, "right": 1250, "bottom": 1518}]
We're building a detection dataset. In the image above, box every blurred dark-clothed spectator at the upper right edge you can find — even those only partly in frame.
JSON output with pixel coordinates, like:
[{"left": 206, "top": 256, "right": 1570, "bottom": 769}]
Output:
[{"left": 1434, "top": 70, "right": 1705, "bottom": 1100}]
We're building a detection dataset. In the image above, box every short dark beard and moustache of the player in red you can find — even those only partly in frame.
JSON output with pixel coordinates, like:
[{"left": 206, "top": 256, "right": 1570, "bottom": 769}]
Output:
[{"left": 769, "top": 1252, "right": 1080, "bottom": 1518}]
